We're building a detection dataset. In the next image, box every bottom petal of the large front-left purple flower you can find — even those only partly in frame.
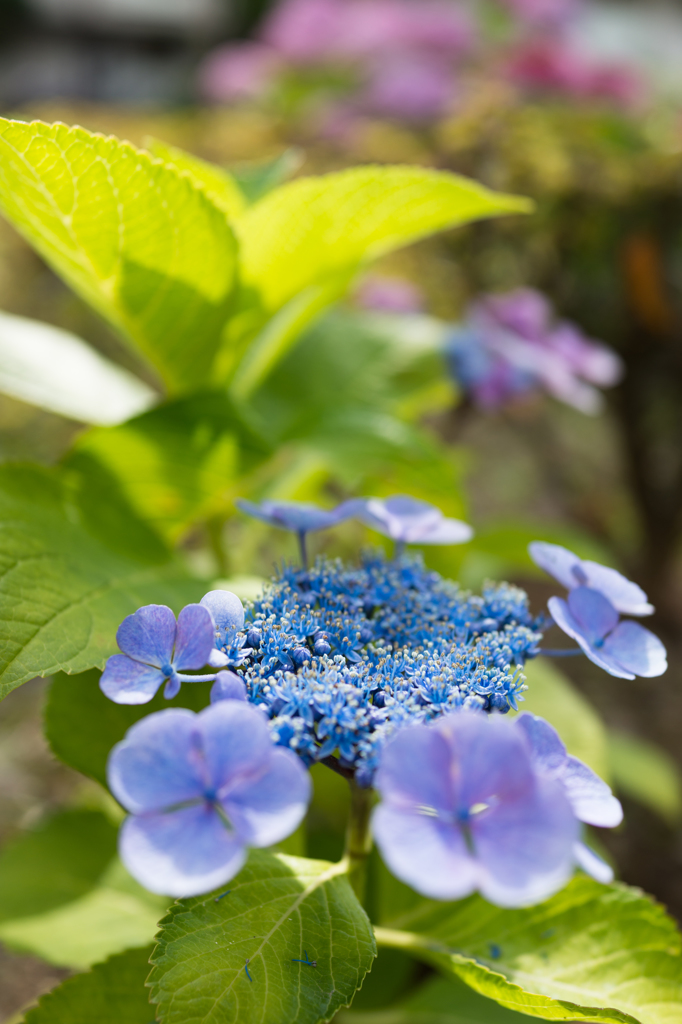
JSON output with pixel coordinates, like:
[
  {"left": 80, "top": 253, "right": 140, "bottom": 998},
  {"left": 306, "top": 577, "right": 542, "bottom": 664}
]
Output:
[{"left": 119, "top": 804, "right": 246, "bottom": 896}]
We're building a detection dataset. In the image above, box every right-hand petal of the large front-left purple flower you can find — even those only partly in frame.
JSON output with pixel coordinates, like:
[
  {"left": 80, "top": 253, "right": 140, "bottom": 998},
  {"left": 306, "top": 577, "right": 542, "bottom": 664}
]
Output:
[{"left": 222, "top": 748, "right": 310, "bottom": 846}]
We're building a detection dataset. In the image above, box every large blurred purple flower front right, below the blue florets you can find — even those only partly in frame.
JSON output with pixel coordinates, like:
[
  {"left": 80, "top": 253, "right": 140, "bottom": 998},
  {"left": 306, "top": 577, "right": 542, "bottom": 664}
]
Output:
[{"left": 373, "top": 711, "right": 579, "bottom": 906}]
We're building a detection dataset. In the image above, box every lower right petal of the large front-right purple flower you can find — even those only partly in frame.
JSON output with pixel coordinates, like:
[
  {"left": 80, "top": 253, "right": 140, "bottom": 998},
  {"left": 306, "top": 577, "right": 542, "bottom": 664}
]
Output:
[{"left": 470, "top": 777, "right": 578, "bottom": 906}]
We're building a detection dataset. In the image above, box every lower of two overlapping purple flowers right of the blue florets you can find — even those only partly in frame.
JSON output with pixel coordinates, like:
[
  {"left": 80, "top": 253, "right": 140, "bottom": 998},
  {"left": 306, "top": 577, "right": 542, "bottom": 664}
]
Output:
[{"left": 547, "top": 587, "right": 668, "bottom": 679}]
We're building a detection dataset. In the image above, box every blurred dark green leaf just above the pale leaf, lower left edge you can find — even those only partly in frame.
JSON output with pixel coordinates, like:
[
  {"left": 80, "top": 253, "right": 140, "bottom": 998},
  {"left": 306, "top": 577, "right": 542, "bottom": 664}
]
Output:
[{"left": 0, "top": 810, "right": 117, "bottom": 922}]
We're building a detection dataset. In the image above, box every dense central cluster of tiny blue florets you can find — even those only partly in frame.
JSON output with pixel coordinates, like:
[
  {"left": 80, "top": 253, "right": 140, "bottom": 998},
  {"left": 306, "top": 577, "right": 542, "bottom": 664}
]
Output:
[{"left": 215, "top": 554, "right": 542, "bottom": 784}]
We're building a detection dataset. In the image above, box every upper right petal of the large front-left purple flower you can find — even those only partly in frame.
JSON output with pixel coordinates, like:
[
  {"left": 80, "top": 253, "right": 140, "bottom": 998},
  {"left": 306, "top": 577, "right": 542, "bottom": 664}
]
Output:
[{"left": 196, "top": 700, "right": 274, "bottom": 800}]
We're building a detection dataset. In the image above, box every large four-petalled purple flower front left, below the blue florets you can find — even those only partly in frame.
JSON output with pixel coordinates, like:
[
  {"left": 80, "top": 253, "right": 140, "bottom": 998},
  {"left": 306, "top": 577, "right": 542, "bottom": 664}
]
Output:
[{"left": 108, "top": 700, "right": 310, "bottom": 897}]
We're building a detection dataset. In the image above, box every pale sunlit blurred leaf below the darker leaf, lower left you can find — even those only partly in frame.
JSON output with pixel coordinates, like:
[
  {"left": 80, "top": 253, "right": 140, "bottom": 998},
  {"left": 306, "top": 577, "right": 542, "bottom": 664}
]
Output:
[{"left": 0, "top": 859, "right": 166, "bottom": 971}]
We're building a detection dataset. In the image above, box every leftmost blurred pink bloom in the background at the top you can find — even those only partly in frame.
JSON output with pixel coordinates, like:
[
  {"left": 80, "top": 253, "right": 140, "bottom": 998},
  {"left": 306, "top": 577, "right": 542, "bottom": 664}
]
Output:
[{"left": 199, "top": 42, "right": 281, "bottom": 101}]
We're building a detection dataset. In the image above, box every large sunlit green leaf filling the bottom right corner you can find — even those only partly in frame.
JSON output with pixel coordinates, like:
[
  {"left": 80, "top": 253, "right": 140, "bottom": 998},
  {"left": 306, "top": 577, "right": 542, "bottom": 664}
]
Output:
[{"left": 376, "top": 876, "right": 682, "bottom": 1024}]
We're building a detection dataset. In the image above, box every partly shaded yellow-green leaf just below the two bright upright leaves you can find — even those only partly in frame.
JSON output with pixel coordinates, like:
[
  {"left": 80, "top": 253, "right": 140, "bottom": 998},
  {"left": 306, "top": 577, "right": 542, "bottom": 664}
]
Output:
[{"left": 66, "top": 392, "right": 269, "bottom": 542}]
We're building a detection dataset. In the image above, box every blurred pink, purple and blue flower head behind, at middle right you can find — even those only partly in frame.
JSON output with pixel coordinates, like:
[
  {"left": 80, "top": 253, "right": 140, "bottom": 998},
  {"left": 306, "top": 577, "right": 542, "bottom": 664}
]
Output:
[{"left": 445, "top": 288, "right": 623, "bottom": 414}]
